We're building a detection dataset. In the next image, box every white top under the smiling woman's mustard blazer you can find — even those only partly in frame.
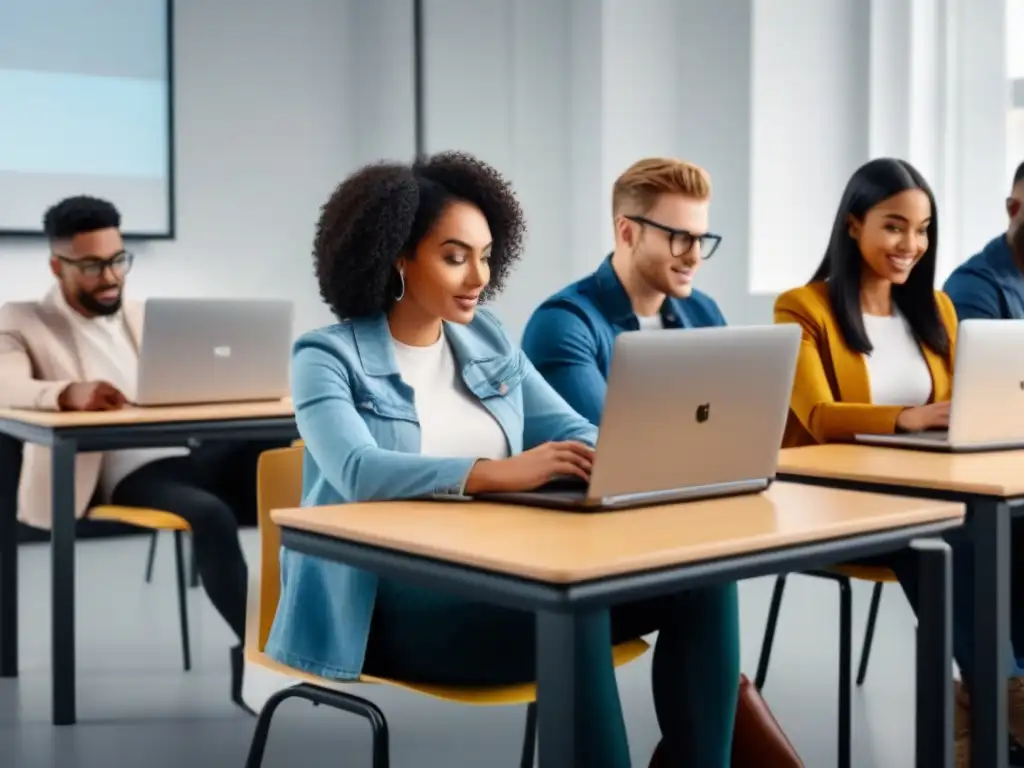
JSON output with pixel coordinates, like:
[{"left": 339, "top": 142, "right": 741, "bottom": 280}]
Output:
[{"left": 864, "top": 313, "right": 932, "bottom": 407}]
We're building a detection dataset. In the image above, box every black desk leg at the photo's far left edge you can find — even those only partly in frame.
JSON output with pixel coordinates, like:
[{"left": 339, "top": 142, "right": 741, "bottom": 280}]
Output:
[{"left": 0, "top": 435, "right": 22, "bottom": 677}]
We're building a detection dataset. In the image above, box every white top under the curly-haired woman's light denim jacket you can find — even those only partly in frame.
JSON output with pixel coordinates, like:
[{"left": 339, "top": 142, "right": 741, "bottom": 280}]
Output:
[{"left": 394, "top": 333, "right": 509, "bottom": 459}]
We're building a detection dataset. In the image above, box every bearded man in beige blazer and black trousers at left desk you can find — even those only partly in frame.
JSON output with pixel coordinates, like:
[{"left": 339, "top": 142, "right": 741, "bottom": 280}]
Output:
[{"left": 0, "top": 197, "right": 264, "bottom": 710}]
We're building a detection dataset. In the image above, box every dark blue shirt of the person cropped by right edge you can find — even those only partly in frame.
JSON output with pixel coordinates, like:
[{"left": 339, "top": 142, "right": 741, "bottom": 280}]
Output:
[{"left": 943, "top": 234, "right": 1024, "bottom": 321}]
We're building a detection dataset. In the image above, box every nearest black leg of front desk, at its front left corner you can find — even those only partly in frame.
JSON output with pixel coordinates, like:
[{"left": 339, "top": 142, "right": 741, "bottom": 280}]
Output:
[{"left": 537, "top": 611, "right": 599, "bottom": 768}]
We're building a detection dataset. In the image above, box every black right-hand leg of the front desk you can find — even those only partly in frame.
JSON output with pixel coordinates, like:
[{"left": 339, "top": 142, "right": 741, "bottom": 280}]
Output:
[{"left": 910, "top": 539, "right": 953, "bottom": 768}]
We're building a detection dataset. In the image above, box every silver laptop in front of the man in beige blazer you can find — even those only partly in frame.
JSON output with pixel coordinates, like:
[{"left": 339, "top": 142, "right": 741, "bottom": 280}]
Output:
[{"left": 134, "top": 299, "right": 292, "bottom": 406}]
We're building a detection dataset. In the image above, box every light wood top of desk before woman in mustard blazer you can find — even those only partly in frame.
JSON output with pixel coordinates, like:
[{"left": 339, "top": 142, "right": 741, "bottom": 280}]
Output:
[{"left": 778, "top": 443, "right": 1024, "bottom": 499}]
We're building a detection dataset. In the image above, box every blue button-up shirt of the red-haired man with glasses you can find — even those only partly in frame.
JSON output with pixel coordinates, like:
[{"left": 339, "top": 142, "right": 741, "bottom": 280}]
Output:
[{"left": 522, "top": 257, "right": 725, "bottom": 424}]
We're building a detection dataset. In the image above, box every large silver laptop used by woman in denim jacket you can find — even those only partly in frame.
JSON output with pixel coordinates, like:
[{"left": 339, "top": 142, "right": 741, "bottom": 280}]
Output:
[{"left": 477, "top": 325, "right": 801, "bottom": 512}]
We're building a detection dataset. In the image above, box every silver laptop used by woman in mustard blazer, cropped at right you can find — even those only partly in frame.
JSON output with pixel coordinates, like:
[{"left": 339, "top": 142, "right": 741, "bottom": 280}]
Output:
[{"left": 856, "top": 319, "right": 1024, "bottom": 452}]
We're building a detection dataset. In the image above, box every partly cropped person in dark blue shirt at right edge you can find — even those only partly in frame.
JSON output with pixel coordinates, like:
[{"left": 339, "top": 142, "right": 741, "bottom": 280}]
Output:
[{"left": 943, "top": 163, "right": 1024, "bottom": 321}]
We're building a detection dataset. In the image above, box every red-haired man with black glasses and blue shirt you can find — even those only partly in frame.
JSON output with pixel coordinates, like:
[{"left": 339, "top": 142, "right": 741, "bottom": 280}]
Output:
[{"left": 522, "top": 158, "right": 802, "bottom": 768}]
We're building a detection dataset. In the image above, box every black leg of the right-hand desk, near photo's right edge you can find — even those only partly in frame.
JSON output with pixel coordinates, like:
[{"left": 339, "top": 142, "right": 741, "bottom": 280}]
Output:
[{"left": 966, "top": 501, "right": 1010, "bottom": 768}]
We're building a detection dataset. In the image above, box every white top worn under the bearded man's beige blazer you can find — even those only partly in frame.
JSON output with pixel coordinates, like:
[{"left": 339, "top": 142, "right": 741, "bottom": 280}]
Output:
[{"left": 56, "top": 291, "right": 188, "bottom": 502}]
